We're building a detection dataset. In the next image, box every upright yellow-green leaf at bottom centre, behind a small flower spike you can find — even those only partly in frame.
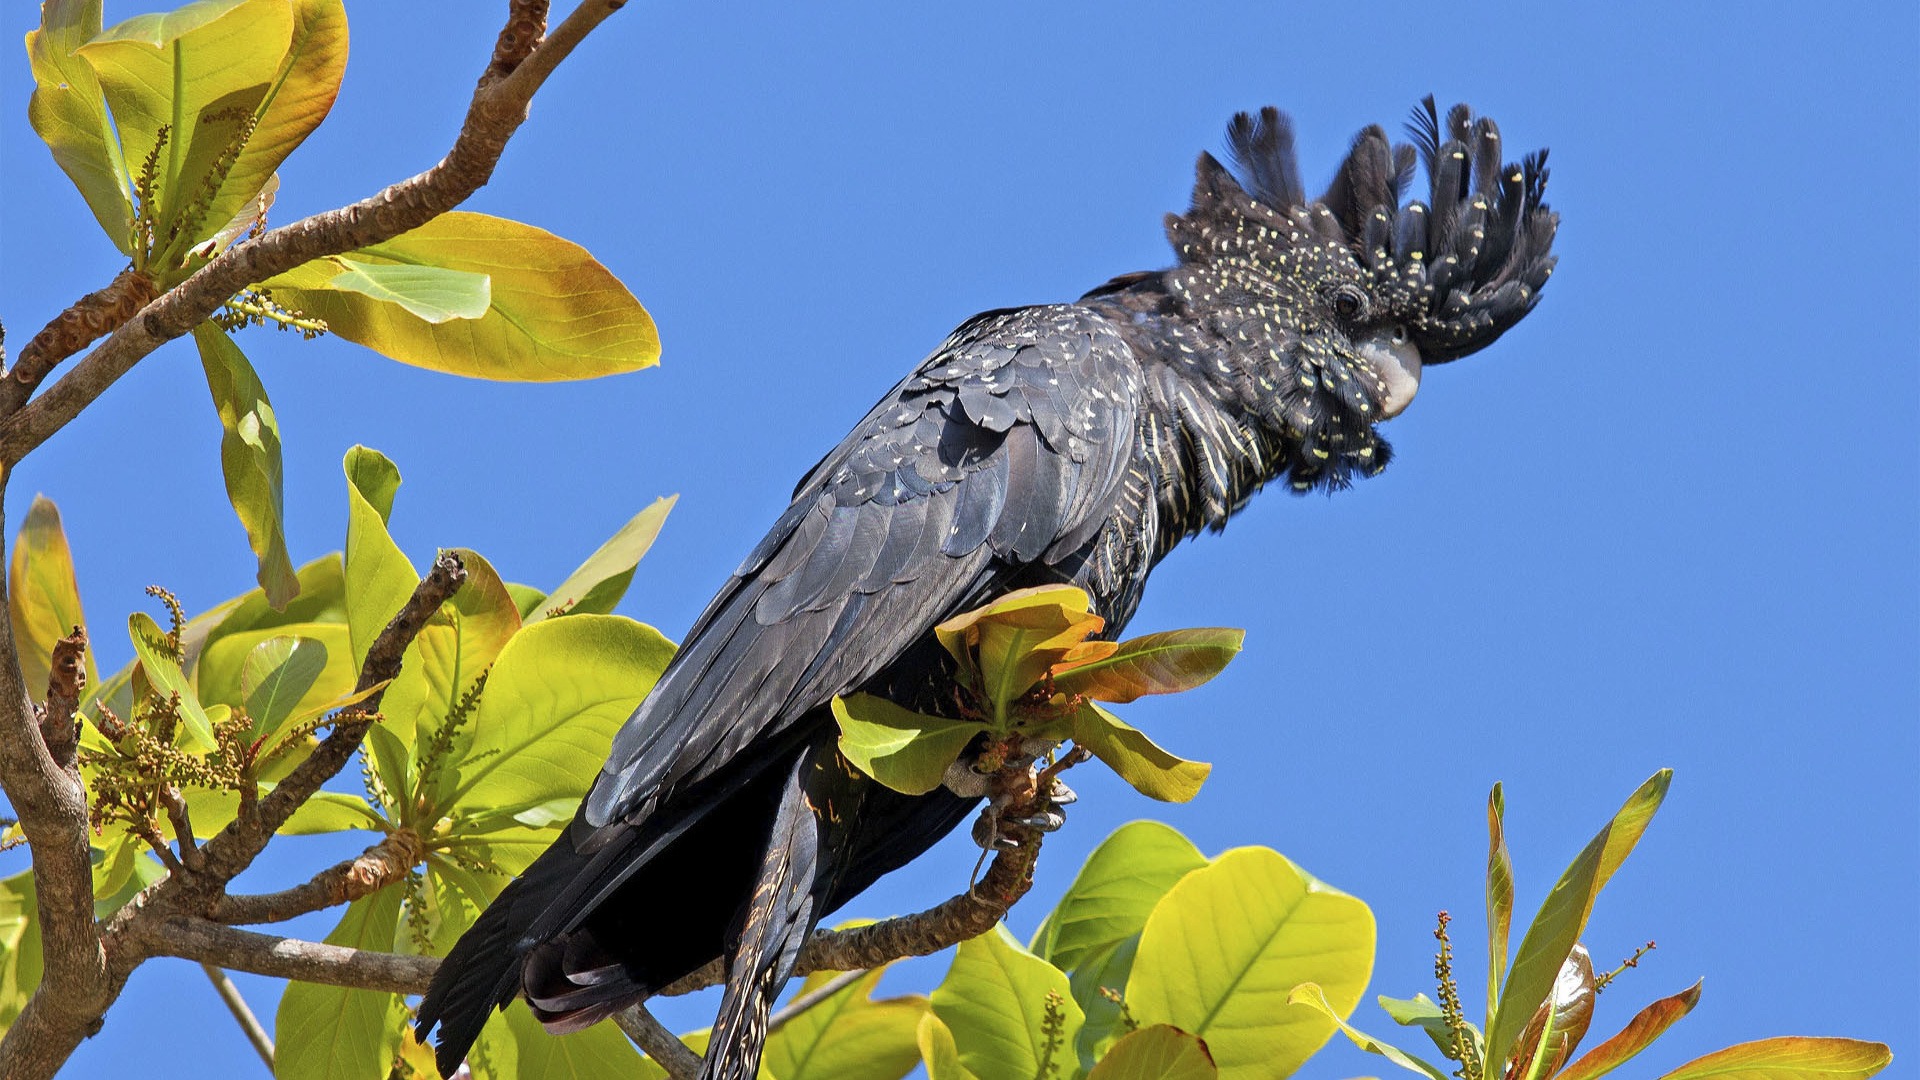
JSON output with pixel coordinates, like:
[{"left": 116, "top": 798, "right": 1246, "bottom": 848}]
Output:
[{"left": 931, "top": 924, "right": 1085, "bottom": 1078}]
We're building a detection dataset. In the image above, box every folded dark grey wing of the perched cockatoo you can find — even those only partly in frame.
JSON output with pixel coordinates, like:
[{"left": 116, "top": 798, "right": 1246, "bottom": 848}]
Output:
[{"left": 584, "top": 306, "right": 1140, "bottom": 834}]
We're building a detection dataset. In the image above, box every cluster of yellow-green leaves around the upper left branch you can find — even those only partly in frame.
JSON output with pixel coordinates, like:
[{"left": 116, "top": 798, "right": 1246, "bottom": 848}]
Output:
[{"left": 27, "top": 0, "right": 660, "bottom": 609}]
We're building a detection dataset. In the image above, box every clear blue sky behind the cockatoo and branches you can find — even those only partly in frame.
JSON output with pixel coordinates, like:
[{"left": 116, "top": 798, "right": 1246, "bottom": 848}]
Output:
[{"left": 0, "top": 0, "right": 1920, "bottom": 1080}]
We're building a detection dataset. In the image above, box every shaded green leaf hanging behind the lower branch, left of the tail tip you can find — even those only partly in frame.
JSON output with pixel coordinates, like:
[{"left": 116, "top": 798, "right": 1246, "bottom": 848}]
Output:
[{"left": 273, "top": 886, "right": 407, "bottom": 1080}]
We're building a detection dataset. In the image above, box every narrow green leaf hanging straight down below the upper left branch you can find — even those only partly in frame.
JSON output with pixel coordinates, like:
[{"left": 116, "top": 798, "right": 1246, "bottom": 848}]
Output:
[{"left": 194, "top": 323, "right": 300, "bottom": 607}]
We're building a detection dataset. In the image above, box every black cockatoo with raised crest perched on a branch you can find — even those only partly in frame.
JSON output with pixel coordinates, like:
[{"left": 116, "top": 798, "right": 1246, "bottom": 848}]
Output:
[{"left": 417, "top": 96, "right": 1559, "bottom": 1080}]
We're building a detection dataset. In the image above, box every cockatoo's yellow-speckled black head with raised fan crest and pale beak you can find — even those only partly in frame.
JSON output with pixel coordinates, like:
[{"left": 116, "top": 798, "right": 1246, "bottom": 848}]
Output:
[{"left": 1144, "top": 98, "right": 1559, "bottom": 486}]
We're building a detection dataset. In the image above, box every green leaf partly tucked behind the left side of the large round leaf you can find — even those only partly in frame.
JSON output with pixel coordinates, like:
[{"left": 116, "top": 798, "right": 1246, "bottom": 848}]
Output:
[{"left": 1033, "top": 821, "right": 1206, "bottom": 968}]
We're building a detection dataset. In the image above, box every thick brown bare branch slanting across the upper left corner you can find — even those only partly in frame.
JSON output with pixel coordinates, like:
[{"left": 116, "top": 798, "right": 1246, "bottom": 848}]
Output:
[{"left": 0, "top": 0, "right": 626, "bottom": 463}]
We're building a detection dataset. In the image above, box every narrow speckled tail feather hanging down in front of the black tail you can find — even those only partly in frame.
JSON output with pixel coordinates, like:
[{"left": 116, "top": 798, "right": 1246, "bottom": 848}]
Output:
[{"left": 701, "top": 744, "right": 833, "bottom": 1080}]
